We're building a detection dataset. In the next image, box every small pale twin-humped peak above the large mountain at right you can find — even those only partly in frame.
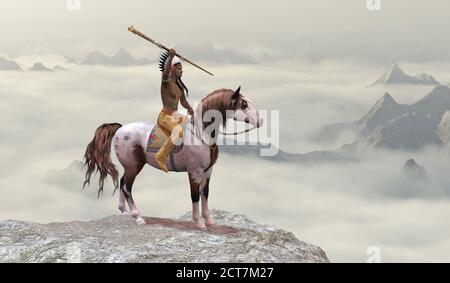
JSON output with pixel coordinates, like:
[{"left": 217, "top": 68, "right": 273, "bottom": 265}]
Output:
[{"left": 373, "top": 64, "right": 440, "bottom": 85}]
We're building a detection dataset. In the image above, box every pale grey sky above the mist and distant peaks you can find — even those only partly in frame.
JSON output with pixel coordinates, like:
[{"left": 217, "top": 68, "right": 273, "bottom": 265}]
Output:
[{"left": 0, "top": 0, "right": 450, "bottom": 59}]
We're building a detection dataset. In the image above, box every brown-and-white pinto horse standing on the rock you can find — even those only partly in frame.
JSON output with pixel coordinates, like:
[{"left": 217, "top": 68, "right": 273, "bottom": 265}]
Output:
[{"left": 83, "top": 87, "right": 263, "bottom": 230}]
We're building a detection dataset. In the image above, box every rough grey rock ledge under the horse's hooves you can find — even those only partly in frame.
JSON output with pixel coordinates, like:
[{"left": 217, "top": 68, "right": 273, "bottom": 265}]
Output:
[{"left": 0, "top": 210, "right": 328, "bottom": 262}]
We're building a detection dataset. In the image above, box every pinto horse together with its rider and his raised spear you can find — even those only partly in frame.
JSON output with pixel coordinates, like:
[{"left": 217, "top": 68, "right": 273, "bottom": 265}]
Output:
[{"left": 83, "top": 26, "right": 263, "bottom": 230}]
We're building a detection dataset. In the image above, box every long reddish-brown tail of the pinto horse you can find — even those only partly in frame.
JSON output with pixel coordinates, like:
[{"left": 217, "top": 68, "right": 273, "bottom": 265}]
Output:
[{"left": 83, "top": 123, "right": 122, "bottom": 197}]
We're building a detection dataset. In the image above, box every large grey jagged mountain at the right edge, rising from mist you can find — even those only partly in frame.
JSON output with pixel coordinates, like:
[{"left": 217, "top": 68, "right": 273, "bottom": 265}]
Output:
[{"left": 307, "top": 86, "right": 450, "bottom": 151}]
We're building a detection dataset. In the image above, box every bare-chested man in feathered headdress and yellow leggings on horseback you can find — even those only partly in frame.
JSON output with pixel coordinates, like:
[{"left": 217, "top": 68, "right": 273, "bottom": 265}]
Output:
[{"left": 155, "top": 49, "right": 194, "bottom": 173}]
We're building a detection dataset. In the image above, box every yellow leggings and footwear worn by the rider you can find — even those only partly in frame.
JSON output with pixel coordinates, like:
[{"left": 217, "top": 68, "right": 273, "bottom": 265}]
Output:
[{"left": 155, "top": 111, "right": 186, "bottom": 173}]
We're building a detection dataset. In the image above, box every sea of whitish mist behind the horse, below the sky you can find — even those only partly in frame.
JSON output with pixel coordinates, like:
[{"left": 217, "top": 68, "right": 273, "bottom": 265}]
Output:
[{"left": 0, "top": 58, "right": 450, "bottom": 261}]
